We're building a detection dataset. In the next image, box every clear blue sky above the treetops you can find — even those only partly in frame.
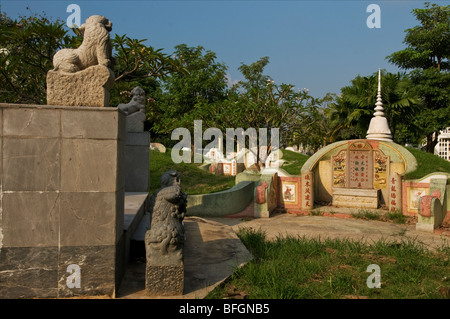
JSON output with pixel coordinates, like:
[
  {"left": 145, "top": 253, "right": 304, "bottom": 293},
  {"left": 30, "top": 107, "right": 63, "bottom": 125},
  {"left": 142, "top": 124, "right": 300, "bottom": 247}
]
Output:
[{"left": 0, "top": 0, "right": 450, "bottom": 97}]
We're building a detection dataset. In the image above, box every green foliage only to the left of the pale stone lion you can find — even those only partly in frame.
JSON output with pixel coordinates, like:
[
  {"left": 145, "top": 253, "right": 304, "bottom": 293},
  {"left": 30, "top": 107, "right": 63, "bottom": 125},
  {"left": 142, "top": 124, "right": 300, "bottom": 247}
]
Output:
[{"left": 0, "top": 13, "right": 80, "bottom": 104}]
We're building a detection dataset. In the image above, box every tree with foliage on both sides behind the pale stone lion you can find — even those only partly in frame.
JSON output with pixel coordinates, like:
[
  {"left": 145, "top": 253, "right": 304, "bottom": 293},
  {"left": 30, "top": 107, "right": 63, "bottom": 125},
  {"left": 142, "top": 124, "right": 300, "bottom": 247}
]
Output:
[{"left": 0, "top": 9, "right": 183, "bottom": 106}]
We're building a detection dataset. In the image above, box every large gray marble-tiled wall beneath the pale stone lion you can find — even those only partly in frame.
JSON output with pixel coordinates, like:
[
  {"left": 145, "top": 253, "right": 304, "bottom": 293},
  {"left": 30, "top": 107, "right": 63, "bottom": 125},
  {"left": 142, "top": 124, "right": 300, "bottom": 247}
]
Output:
[{"left": 0, "top": 104, "right": 125, "bottom": 298}]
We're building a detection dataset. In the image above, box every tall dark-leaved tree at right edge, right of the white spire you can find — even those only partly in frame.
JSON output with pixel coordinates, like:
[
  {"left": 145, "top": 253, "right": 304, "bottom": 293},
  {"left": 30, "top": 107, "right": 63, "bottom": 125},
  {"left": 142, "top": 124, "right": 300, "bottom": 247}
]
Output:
[{"left": 387, "top": 2, "right": 450, "bottom": 153}]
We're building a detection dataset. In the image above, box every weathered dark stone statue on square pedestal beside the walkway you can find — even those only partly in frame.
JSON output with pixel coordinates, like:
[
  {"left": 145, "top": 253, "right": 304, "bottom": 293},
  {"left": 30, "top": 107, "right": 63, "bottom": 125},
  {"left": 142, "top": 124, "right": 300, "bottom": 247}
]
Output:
[{"left": 145, "top": 171, "right": 187, "bottom": 295}]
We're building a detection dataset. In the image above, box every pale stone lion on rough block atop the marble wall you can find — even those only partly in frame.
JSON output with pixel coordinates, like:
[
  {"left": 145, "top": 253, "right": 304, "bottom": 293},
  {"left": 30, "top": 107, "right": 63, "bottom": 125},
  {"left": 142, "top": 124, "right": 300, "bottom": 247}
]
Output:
[{"left": 47, "top": 15, "right": 114, "bottom": 107}]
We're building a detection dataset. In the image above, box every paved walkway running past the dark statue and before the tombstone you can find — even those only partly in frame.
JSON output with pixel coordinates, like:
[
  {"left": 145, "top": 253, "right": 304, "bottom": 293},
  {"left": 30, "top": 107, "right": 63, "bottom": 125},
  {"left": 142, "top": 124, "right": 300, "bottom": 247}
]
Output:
[{"left": 117, "top": 214, "right": 450, "bottom": 299}]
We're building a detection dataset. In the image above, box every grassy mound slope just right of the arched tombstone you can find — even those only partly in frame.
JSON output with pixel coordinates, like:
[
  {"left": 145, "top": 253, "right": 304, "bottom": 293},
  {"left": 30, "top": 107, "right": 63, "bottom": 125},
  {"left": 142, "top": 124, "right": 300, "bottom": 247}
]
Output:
[{"left": 404, "top": 147, "right": 450, "bottom": 179}]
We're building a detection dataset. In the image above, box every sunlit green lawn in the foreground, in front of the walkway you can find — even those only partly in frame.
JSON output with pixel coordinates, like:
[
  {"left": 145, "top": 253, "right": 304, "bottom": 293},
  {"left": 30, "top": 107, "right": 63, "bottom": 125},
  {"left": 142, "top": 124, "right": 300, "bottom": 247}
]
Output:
[{"left": 207, "top": 229, "right": 450, "bottom": 299}]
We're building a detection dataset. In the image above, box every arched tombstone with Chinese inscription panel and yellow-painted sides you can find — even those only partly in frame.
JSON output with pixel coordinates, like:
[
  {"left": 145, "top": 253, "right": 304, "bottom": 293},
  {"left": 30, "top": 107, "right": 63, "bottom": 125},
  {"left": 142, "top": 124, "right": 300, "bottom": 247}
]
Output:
[{"left": 302, "top": 139, "right": 417, "bottom": 211}]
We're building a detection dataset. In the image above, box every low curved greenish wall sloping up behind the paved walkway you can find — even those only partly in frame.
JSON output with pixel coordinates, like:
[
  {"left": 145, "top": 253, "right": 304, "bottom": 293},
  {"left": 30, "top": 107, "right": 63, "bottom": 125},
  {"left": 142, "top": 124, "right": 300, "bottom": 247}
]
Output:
[{"left": 187, "top": 181, "right": 255, "bottom": 217}]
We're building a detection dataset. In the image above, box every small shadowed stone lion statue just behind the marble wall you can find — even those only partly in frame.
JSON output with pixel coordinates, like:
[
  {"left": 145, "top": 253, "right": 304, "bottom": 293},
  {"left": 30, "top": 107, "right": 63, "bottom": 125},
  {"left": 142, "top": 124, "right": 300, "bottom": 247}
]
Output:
[{"left": 117, "top": 86, "right": 146, "bottom": 132}]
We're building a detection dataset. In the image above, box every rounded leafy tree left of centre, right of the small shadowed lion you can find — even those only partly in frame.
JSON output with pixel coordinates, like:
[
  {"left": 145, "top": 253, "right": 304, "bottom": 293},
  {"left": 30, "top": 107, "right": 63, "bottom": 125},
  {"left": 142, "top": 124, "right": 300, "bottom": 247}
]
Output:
[{"left": 149, "top": 44, "right": 227, "bottom": 142}]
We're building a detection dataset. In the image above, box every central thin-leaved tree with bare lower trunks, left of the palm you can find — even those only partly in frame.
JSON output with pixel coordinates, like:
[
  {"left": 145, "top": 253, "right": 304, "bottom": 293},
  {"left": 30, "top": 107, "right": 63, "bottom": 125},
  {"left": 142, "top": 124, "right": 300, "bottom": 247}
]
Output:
[{"left": 224, "top": 57, "right": 318, "bottom": 166}]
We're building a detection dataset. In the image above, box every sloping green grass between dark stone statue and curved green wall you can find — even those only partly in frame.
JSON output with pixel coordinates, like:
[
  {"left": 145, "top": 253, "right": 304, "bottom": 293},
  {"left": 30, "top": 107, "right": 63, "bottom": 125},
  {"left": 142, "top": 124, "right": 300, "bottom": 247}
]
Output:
[{"left": 150, "top": 149, "right": 235, "bottom": 195}]
